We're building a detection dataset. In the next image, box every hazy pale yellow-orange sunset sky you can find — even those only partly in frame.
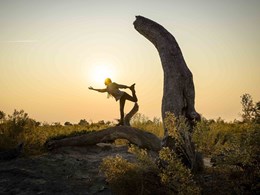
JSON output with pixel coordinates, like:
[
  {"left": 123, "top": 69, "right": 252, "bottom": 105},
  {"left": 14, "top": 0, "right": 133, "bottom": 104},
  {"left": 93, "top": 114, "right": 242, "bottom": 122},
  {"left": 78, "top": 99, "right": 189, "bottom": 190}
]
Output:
[{"left": 0, "top": 0, "right": 260, "bottom": 123}]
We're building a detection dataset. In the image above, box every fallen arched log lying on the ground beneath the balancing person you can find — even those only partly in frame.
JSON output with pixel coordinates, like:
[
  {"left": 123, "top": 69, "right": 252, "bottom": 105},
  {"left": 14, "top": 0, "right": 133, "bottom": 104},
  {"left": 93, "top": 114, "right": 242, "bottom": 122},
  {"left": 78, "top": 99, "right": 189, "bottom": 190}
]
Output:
[{"left": 47, "top": 126, "right": 161, "bottom": 151}]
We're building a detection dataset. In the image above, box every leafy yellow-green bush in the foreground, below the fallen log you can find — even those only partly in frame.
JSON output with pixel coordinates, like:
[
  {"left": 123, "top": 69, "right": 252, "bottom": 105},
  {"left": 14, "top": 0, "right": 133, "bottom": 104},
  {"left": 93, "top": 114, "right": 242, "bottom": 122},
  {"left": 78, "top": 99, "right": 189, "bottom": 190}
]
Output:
[{"left": 100, "top": 146, "right": 200, "bottom": 194}]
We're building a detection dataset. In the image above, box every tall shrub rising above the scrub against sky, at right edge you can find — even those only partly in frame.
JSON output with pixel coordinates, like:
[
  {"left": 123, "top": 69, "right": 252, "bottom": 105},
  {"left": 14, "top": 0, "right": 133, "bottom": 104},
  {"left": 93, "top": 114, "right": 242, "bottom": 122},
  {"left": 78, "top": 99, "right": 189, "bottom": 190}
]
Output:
[{"left": 241, "top": 93, "right": 260, "bottom": 123}]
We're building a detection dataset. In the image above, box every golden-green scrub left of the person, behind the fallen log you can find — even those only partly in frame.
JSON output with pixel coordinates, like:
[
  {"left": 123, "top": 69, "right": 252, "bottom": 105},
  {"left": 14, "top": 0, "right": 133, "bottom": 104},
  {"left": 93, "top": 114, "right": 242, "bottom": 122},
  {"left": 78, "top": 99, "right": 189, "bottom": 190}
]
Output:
[{"left": 0, "top": 110, "right": 111, "bottom": 155}]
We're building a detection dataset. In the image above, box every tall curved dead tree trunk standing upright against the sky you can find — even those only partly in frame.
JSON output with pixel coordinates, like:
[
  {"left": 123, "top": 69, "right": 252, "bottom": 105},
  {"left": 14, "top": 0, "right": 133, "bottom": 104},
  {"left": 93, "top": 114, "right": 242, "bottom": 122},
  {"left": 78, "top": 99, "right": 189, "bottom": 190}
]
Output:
[{"left": 134, "top": 16, "right": 200, "bottom": 171}]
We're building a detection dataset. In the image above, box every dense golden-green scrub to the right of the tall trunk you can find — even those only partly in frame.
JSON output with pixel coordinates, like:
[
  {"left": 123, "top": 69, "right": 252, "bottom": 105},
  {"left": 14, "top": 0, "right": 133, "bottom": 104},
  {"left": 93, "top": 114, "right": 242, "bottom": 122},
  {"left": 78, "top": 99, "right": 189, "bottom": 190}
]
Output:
[{"left": 193, "top": 94, "right": 260, "bottom": 194}]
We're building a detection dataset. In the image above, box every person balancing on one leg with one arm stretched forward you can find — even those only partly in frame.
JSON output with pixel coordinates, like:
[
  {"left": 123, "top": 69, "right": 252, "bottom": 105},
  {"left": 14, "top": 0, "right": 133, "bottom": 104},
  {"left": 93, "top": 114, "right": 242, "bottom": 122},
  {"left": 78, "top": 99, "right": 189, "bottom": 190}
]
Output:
[{"left": 89, "top": 78, "right": 138, "bottom": 126}]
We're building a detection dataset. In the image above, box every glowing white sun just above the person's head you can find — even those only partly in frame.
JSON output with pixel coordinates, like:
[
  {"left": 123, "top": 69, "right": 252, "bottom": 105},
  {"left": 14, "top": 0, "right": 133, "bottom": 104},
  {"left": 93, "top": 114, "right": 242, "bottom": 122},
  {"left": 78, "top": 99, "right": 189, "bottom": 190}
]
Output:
[{"left": 91, "top": 64, "right": 115, "bottom": 83}]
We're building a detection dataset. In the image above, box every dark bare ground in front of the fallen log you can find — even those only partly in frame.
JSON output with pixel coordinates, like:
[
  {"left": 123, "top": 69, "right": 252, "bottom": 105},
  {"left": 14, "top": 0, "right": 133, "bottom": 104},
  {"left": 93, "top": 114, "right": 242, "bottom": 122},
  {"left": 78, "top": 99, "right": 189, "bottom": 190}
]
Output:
[{"left": 0, "top": 144, "right": 134, "bottom": 195}]
